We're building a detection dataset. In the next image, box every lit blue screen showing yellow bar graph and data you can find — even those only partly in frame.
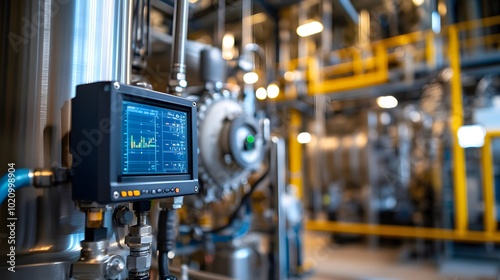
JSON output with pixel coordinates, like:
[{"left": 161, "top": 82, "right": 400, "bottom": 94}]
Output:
[{"left": 122, "top": 100, "right": 189, "bottom": 175}]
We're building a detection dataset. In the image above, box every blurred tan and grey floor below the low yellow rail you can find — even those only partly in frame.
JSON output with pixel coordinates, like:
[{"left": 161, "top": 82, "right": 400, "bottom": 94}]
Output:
[{"left": 304, "top": 232, "right": 498, "bottom": 280}]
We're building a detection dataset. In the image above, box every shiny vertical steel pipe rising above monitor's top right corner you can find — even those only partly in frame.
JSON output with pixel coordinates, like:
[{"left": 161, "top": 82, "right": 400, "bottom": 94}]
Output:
[{"left": 167, "top": 0, "right": 189, "bottom": 96}]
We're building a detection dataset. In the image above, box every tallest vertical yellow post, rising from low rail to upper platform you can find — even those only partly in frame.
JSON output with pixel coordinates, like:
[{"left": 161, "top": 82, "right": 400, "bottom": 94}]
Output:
[{"left": 448, "top": 26, "right": 468, "bottom": 232}]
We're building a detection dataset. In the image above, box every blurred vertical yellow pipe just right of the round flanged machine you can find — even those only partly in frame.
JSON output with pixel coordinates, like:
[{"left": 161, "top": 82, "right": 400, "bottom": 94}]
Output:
[{"left": 288, "top": 110, "right": 303, "bottom": 199}]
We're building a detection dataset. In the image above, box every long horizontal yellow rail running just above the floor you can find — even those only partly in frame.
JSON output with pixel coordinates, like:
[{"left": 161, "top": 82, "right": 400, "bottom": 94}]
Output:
[{"left": 305, "top": 221, "right": 500, "bottom": 243}]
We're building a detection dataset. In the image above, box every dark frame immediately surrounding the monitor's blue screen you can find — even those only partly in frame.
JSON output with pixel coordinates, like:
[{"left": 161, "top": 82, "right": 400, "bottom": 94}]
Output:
[{"left": 110, "top": 89, "right": 197, "bottom": 183}]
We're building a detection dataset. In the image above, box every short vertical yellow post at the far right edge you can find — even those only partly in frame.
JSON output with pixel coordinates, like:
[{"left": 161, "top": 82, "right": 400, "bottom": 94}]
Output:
[{"left": 481, "top": 133, "right": 496, "bottom": 234}]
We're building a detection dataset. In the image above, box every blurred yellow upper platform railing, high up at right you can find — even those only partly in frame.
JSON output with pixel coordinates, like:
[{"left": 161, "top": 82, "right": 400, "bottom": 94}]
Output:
[{"left": 286, "top": 16, "right": 500, "bottom": 98}]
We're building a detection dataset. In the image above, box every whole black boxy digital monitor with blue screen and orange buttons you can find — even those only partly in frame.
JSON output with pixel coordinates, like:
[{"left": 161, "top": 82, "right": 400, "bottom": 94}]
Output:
[{"left": 70, "top": 82, "right": 199, "bottom": 204}]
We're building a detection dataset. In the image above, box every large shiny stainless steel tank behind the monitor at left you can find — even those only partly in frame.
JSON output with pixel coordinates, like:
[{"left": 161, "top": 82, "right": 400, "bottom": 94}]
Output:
[{"left": 0, "top": 0, "right": 132, "bottom": 279}]
